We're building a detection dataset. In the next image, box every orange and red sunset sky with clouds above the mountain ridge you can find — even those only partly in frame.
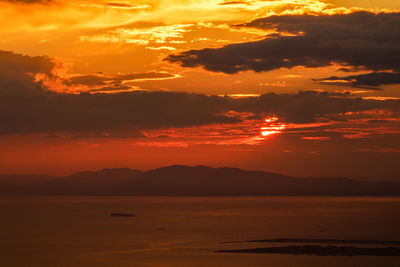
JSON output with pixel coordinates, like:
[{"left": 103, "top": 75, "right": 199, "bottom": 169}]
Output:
[{"left": 0, "top": 0, "right": 400, "bottom": 181}]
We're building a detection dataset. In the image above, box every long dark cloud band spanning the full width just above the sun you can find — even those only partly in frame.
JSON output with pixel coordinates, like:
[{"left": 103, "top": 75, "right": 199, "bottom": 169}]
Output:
[{"left": 0, "top": 49, "right": 400, "bottom": 137}]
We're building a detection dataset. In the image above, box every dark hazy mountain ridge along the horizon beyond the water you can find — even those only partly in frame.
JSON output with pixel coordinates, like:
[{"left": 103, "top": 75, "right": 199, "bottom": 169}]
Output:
[{"left": 0, "top": 165, "right": 400, "bottom": 196}]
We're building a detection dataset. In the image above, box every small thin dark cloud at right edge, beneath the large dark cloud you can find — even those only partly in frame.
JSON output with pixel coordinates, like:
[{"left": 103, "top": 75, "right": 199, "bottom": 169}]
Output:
[{"left": 314, "top": 72, "right": 400, "bottom": 90}]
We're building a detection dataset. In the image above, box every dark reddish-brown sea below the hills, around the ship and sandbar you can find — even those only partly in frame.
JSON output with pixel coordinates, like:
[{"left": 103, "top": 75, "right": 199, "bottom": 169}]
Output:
[{"left": 0, "top": 197, "right": 400, "bottom": 267}]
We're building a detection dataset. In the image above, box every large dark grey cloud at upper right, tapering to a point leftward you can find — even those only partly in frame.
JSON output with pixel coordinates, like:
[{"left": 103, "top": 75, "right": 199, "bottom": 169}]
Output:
[{"left": 166, "top": 12, "right": 400, "bottom": 73}]
